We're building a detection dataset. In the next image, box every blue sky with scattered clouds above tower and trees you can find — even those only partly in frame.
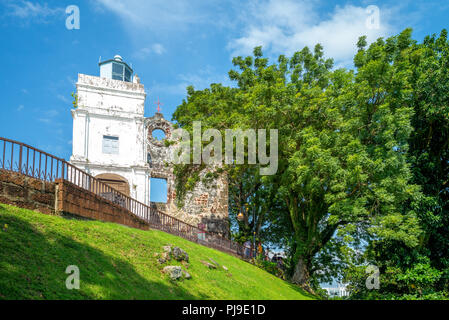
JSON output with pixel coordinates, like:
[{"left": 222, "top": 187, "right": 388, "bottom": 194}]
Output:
[{"left": 0, "top": 0, "right": 449, "bottom": 201}]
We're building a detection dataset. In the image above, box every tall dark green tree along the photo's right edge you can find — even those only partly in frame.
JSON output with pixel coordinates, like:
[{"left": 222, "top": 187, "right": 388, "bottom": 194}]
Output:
[{"left": 410, "top": 30, "right": 449, "bottom": 292}]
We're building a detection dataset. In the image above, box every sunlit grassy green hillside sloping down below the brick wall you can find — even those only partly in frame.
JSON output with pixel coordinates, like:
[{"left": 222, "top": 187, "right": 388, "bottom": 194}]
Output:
[{"left": 0, "top": 204, "right": 312, "bottom": 299}]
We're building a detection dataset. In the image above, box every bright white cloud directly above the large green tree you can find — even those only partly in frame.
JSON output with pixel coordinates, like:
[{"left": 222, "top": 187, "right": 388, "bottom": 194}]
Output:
[{"left": 228, "top": 0, "right": 392, "bottom": 66}]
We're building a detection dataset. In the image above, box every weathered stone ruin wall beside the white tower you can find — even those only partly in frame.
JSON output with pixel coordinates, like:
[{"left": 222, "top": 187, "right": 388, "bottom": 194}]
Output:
[{"left": 145, "top": 113, "right": 230, "bottom": 237}]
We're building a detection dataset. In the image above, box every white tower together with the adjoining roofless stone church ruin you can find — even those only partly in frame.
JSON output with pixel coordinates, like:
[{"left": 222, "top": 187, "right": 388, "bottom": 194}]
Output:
[{"left": 70, "top": 56, "right": 229, "bottom": 236}]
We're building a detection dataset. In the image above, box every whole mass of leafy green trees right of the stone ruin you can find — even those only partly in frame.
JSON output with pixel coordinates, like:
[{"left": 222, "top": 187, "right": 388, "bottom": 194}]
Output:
[{"left": 173, "top": 29, "right": 449, "bottom": 295}]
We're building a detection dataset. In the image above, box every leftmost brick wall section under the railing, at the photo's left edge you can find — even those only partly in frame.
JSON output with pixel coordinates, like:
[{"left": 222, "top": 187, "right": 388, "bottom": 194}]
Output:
[{"left": 0, "top": 169, "right": 55, "bottom": 214}]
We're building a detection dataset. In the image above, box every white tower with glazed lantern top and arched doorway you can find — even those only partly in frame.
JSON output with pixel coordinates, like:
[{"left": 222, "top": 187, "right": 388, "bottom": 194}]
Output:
[{"left": 70, "top": 55, "right": 150, "bottom": 204}]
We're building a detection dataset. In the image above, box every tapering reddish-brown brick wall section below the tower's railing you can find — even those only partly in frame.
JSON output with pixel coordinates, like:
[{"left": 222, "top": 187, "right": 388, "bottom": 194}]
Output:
[{"left": 56, "top": 179, "right": 149, "bottom": 230}]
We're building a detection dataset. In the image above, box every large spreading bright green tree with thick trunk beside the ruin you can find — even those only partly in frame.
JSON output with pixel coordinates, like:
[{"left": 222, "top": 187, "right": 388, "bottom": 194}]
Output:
[{"left": 173, "top": 35, "right": 419, "bottom": 290}]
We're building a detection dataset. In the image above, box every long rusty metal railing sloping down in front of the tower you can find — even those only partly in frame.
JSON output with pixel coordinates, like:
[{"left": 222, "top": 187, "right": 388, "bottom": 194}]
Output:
[{"left": 0, "top": 137, "right": 244, "bottom": 256}]
